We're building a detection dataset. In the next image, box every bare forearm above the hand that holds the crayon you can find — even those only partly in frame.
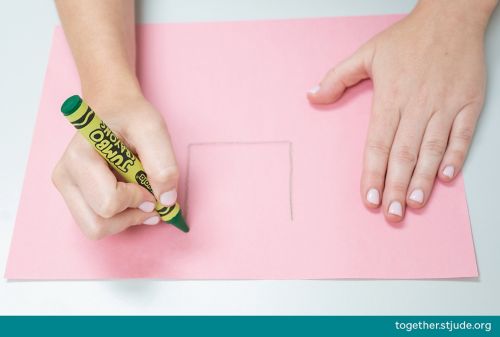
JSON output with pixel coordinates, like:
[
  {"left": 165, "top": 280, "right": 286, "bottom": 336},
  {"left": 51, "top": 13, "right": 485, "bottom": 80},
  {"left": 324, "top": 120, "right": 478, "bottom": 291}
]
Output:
[{"left": 56, "top": 0, "right": 140, "bottom": 102}]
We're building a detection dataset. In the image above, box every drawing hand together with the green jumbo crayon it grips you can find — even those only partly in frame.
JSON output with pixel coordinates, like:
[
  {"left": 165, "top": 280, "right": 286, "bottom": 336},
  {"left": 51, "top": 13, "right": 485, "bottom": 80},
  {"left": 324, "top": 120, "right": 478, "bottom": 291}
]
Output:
[{"left": 54, "top": 96, "right": 189, "bottom": 239}]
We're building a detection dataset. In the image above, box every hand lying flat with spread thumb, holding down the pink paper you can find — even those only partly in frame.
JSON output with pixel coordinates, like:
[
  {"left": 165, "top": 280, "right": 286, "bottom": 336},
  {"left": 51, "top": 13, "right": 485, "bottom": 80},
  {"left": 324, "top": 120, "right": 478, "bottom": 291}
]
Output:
[{"left": 308, "top": 1, "right": 494, "bottom": 221}]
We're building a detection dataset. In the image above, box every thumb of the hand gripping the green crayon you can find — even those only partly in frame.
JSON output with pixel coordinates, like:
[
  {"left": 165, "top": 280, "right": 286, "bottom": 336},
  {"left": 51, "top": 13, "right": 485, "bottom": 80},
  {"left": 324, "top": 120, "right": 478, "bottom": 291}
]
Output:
[{"left": 127, "top": 111, "right": 179, "bottom": 206}]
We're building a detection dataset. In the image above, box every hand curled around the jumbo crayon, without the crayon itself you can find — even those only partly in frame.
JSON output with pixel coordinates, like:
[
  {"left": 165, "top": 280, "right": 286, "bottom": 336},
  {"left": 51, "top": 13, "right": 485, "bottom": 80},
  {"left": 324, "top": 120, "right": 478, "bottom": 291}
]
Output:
[{"left": 52, "top": 93, "right": 178, "bottom": 239}]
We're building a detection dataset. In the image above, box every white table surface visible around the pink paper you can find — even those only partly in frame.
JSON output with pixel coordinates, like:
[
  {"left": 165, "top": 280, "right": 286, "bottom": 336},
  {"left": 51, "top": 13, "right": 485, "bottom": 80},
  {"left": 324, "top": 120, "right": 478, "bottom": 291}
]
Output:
[{"left": 0, "top": 0, "right": 500, "bottom": 315}]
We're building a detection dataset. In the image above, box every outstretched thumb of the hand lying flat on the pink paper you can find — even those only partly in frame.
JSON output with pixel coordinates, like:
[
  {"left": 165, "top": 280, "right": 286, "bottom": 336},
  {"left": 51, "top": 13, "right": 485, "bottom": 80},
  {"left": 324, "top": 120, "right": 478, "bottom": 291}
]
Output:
[{"left": 307, "top": 48, "right": 371, "bottom": 104}]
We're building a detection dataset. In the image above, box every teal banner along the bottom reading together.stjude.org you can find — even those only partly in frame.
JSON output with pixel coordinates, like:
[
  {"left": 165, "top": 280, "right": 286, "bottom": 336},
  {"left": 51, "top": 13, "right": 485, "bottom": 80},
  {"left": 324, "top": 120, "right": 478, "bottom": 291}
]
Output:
[{"left": 0, "top": 316, "right": 500, "bottom": 337}]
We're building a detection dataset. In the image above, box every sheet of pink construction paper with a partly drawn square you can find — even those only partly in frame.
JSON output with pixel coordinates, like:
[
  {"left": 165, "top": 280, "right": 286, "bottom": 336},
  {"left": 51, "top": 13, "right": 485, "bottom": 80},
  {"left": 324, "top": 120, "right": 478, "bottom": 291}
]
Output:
[{"left": 6, "top": 16, "right": 478, "bottom": 279}]
